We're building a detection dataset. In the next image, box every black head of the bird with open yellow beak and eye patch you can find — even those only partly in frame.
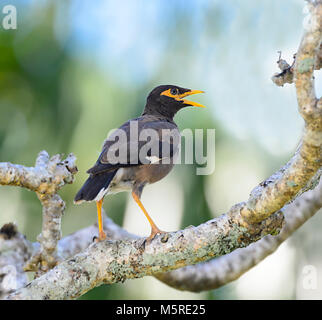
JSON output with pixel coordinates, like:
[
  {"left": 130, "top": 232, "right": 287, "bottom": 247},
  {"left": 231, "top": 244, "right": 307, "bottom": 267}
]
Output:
[{"left": 143, "top": 85, "right": 205, "bottom": 119}]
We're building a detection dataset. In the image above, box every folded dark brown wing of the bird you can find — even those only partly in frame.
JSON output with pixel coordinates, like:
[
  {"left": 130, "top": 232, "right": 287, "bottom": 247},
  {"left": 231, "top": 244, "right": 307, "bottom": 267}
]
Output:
[{"left": 87, "top": 116, "right": 180, "bottom": 175}]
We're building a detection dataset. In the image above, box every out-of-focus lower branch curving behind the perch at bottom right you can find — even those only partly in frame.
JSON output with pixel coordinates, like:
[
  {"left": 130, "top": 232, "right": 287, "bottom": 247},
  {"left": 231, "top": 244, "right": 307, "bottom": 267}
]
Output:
[{"left": 156, "top": 175, "right": 322, "bottom": 292}]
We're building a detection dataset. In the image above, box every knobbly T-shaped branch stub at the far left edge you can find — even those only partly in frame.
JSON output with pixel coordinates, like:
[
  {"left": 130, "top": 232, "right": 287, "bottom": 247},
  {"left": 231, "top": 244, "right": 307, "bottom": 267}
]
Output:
[{"left": 0, "top": 151, "right": 77, "bottom": 276}]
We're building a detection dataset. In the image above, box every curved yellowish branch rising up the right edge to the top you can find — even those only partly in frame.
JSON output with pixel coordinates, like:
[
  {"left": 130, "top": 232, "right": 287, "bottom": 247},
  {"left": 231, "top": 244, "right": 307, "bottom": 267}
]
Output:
[{"left": 241, "top": 0, "right": 322, "bottom": 223}]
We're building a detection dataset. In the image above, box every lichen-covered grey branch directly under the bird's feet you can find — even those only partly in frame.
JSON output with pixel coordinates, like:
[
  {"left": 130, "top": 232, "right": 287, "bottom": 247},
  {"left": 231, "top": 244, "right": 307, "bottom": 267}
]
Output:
[{"left": 8, "top": 206, "right": 283, "bottom": 299}]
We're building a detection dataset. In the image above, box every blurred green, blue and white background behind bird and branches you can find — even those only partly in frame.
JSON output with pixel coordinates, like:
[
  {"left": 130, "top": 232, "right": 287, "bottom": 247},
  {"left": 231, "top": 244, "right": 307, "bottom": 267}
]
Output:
[{"left": 0, "top": 0, "right": 322, "bottom": 299}]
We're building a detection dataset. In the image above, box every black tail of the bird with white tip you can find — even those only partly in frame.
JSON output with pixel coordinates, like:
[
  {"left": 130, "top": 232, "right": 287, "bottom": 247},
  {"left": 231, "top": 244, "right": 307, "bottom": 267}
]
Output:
[{"left": 74, "top": 170, "right": 117, "bottom": 204}]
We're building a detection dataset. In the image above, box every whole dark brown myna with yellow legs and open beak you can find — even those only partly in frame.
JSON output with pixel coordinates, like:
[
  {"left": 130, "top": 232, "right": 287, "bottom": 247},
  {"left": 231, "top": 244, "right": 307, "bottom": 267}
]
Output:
[{"left": 74, "top": 85, "right": 204, "bottom": 241}]
